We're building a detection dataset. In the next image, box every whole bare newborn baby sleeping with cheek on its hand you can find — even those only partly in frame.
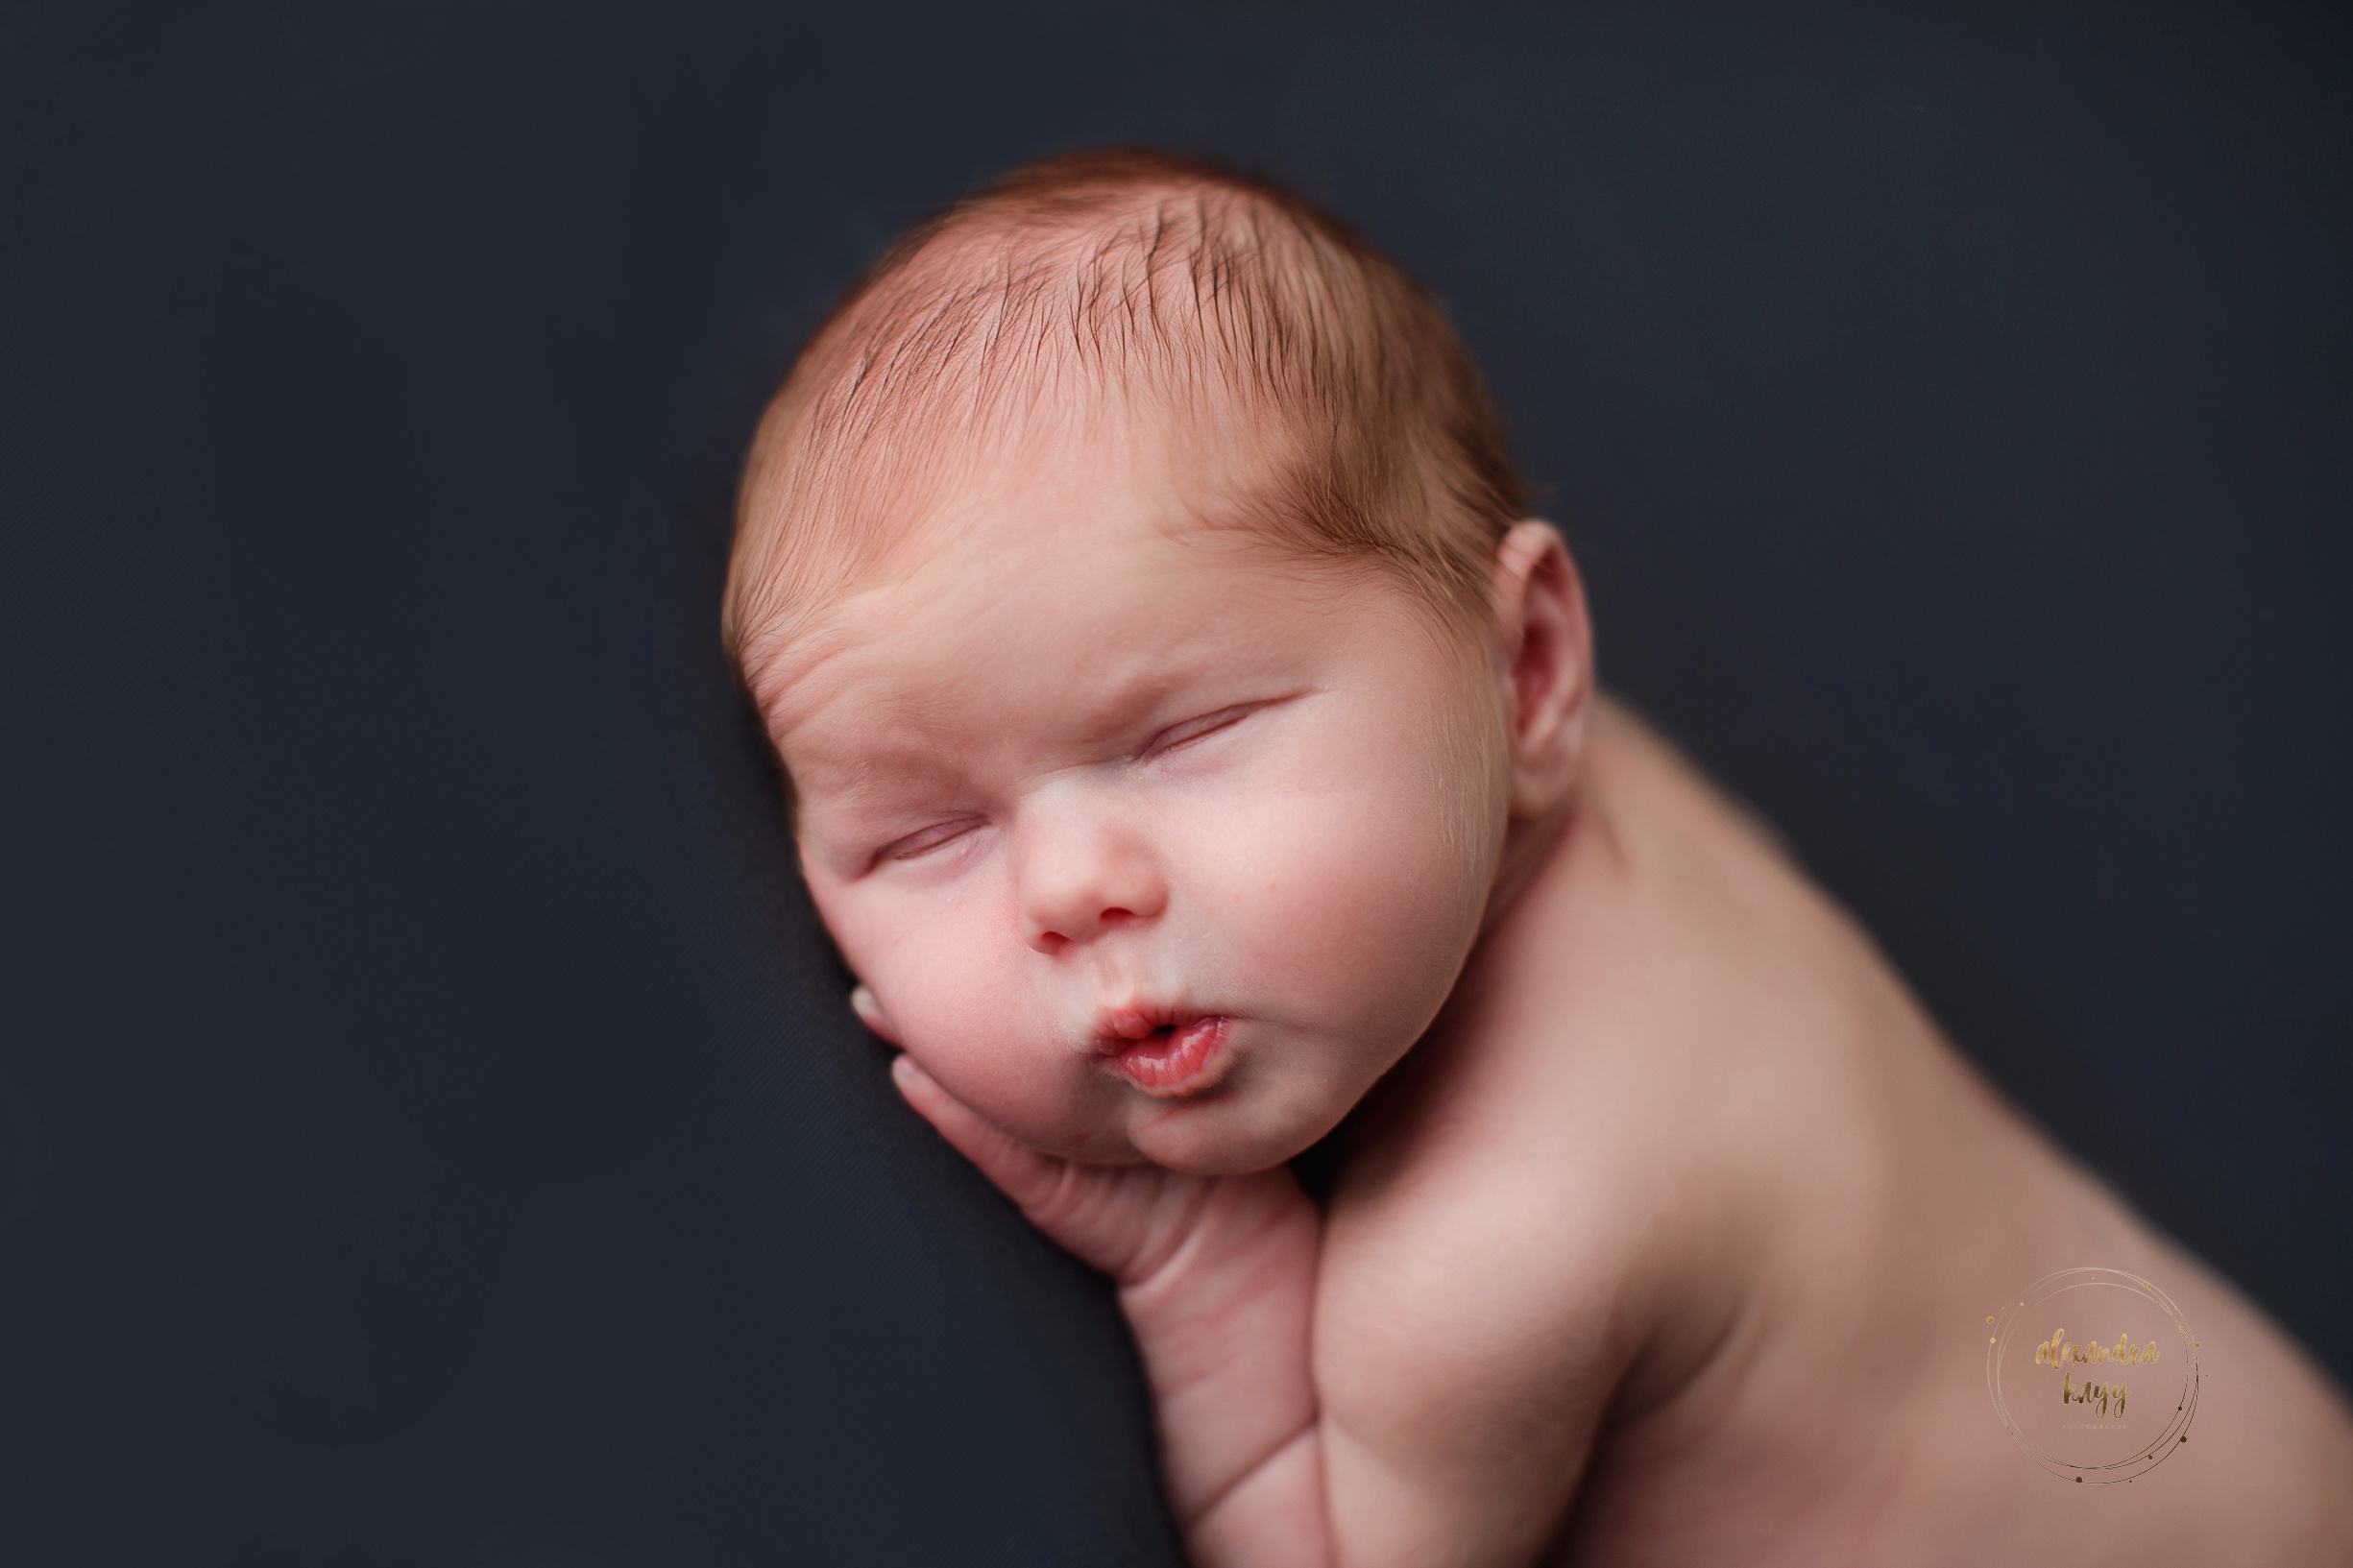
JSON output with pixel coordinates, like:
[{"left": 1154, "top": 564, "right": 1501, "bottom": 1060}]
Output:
[{"left": 725, "top": 153, "right": 2353, "bottom": 1568}]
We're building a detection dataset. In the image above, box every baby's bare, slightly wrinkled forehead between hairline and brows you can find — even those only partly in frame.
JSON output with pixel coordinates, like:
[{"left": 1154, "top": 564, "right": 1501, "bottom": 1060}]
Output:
[{"left": 746, "top": 407, "right": 1459, "bottom": 750}]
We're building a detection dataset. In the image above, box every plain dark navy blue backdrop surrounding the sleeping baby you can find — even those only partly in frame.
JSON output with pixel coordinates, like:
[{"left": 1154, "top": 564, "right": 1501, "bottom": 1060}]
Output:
[{"left": 0, "top": 0, "right": 2353, "bottom": 1568}]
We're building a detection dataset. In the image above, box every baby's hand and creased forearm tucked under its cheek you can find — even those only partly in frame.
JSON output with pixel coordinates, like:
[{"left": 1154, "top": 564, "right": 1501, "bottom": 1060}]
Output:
[{"left": 892, "top": 1055, "right": 1329, "bottom": 1568}]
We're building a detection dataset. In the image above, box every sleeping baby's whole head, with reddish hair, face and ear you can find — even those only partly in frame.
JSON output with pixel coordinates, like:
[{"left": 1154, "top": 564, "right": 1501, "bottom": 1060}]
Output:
[{"left": 725, "top": 151, "right": 1590, "bottom": 1170}]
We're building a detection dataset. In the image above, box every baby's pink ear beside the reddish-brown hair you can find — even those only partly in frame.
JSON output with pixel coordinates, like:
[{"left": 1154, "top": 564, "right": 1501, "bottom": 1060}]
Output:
[{"left": 1494, "top": 522, "right": 1593, "bottom": 816}]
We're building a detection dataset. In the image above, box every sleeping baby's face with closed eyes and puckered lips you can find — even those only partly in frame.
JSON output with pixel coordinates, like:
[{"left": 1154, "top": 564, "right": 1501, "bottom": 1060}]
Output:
[{"left": 767, "top": 430, "right": 1506, "bottom": 1173}]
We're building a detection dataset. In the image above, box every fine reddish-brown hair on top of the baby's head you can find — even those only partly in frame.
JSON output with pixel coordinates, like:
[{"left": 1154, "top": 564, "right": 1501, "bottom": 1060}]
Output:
[{"left": 722, "top": 148, "right": 1527, "bottom": 687}]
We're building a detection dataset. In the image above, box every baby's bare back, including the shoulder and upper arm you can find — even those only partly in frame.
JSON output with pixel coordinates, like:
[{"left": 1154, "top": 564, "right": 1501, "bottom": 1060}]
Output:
[{"left": 1313, "top": 712, "right": 2353, "bottom": 1563}]
